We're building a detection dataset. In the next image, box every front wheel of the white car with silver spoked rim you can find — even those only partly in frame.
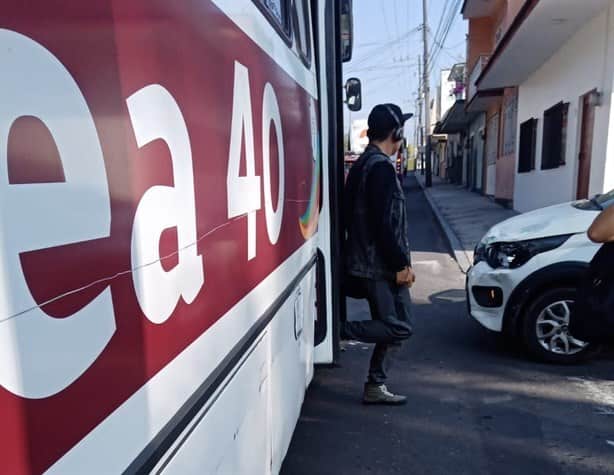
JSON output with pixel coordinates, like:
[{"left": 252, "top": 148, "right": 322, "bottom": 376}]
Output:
[{"left": 523, "top": 288, "right": 595, "bottom": 364}]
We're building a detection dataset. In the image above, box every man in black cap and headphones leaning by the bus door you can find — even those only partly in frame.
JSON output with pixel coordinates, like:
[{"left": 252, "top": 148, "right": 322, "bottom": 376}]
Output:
[{"left": 341, "top": 104, "right": 415, "bottom": 405}]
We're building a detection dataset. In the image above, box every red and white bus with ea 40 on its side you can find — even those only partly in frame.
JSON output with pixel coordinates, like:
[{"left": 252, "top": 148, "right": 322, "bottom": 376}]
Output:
[{"left": 0, "top": 0, "right": 355, "bottom": 474}]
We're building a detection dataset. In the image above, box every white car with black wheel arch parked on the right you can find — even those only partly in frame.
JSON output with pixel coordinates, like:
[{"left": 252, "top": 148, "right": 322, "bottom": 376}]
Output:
[{"left": 467, "top": 190, "right": 614, "bottom": 363}]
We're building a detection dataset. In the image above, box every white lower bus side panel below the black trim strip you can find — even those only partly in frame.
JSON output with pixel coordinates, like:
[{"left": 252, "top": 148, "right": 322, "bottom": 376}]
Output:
[{"left": 156, "top": 268, "right": 315, "bottom": 475}]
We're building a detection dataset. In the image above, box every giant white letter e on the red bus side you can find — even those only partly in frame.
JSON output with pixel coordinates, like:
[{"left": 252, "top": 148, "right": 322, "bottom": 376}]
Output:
[{"left": 0, "top": 29, "right": 115, "bottom": 402}]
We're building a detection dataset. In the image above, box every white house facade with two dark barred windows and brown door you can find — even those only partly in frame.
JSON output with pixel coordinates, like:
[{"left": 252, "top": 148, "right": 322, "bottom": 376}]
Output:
[{"left": 512, "top": 1, "right": 614, "bottom": 211}]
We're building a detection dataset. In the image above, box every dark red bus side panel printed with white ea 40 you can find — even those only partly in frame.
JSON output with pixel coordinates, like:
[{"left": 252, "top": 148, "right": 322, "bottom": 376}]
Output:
[{"left": 0, "top": 0, "right": 321, "bottom": 473}]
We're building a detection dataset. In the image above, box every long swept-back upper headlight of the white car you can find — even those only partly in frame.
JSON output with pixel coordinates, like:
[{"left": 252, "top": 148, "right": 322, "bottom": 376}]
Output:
[{"left": 484, "top": 234, "right": 572, "bottom": 269}]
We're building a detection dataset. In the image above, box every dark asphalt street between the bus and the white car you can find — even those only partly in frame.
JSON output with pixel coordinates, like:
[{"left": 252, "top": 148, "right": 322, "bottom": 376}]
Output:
[{"left": 282, "top": 177, "right": 614, "bottom": 475}]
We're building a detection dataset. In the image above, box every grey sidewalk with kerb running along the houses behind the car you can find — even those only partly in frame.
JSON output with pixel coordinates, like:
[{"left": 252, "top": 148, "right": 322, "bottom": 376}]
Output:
[{"left": 416, "top": 171, "right": 518, "bottom": 272}]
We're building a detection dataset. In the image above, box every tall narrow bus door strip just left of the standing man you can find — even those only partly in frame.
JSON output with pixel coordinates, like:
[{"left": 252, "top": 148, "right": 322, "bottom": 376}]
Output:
[{"left": 311, "top": 0, "right": 360, "bottom": 364}]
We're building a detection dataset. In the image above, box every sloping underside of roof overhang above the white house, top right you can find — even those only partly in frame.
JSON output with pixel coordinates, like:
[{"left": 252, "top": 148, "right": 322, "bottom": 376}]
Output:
[{"left": 482, "top": 0, "right": 610, "bottom": 90}]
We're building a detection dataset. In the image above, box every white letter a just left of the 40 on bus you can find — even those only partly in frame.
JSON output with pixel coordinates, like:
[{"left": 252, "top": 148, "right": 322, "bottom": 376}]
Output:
[{"left": 126, "top": 85, "right": 205, "bottom": 323}]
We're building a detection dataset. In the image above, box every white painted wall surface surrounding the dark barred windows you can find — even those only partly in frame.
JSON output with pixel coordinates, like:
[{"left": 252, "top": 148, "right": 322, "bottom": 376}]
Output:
[{"left": 514, "top": 4, "right": 614, "bottom": 212}]
